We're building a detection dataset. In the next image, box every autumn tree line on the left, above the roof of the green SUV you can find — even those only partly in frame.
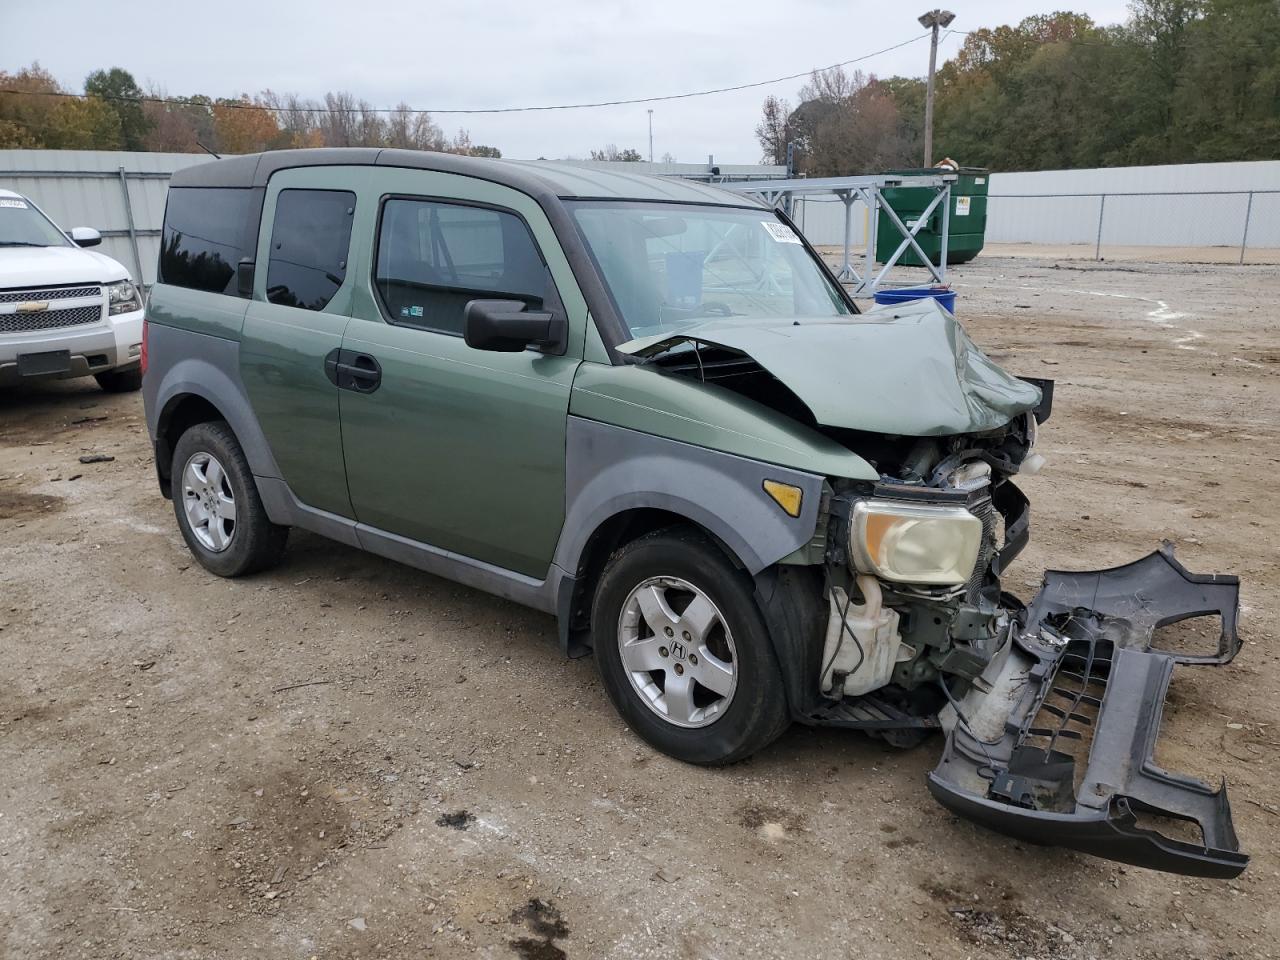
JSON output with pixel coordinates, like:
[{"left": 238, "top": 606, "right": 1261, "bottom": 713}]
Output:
[{"left": 0, "top": 63, "right": 502, "bottom": 156}]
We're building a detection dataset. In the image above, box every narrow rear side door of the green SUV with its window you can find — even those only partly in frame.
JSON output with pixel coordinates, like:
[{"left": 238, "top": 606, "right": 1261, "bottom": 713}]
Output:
[{"left": 241, "top": 166, "right": 367, "bottom": 517}]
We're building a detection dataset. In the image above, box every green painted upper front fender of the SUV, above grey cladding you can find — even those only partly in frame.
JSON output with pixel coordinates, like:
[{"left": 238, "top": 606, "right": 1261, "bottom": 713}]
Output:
[{"left": 570, "top": 364, "right": 879, "bottom": 484}]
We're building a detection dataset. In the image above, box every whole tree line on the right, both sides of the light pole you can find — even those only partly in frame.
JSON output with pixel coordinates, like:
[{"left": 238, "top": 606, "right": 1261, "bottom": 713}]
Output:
[{"left": 755, "top": 0, "right": 1280, "bottom": 177}]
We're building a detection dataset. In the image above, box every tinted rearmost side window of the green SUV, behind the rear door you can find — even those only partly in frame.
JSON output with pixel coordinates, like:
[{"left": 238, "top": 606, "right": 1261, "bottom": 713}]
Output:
[{"left": 159, "top": 187, "right": 257, "bottom": 296}]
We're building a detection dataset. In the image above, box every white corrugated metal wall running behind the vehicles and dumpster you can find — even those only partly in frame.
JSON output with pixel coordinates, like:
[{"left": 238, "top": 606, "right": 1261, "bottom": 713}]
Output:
[{"left": 0, "top": 150, "right": 1280, "bottom": 283}]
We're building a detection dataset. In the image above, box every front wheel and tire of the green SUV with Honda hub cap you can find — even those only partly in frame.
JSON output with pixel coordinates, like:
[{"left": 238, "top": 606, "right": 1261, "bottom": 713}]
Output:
[{"left": 591, "top": 529, "right": 788, "bottom": 765}]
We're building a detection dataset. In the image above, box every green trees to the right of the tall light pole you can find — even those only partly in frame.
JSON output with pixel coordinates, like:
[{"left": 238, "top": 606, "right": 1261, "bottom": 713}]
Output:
[{"left": 934, "top": 0, "right": 1280, "bottom": 170}]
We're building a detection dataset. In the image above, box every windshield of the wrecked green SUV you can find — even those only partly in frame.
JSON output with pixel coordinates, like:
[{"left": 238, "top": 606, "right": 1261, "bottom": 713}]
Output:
[{"left": 571, "top": 201, "right": 854, "bottom": 339}]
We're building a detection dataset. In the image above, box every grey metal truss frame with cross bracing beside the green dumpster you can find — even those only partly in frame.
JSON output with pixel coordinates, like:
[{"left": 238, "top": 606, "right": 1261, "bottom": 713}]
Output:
[{"left": 722, "top": 173, "right": 956, "bottom": 296}]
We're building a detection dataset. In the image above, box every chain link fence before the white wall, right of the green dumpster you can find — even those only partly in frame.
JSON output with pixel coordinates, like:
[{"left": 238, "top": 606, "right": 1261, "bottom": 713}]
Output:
[{"left": 984, "top": 189, "right": 1280, "bottom": 264}]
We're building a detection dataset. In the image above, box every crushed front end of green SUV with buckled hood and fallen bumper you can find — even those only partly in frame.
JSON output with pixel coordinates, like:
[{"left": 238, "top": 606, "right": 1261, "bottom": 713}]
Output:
[{"left": 622, "top": 308, "right": 1248, "bottom": 877}]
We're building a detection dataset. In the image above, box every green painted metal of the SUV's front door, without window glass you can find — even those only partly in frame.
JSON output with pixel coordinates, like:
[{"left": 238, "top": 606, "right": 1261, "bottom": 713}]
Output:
[{"left": 339, "top": 169, "right": 586, "bottom": 577}]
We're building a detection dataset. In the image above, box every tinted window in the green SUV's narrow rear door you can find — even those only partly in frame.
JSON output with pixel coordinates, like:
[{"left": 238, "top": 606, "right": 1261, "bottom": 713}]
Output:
[{"left": 266, "top": 189, "right": 356, "bottom": 316}]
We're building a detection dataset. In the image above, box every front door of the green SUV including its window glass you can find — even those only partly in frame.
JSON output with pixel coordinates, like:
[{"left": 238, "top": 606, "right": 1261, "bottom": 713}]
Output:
[{"left": 340, "top": 169, "right": 586, "bottom": 579}]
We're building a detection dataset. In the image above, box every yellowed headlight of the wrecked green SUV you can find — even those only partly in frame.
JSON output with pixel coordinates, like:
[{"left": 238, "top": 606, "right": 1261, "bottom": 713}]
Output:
[{"left": 849, "top": 499, "right": 983, "bottom": 585}]
